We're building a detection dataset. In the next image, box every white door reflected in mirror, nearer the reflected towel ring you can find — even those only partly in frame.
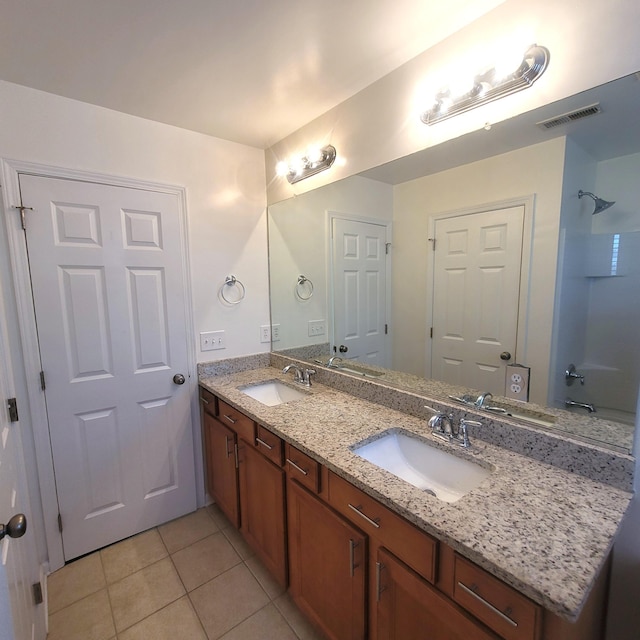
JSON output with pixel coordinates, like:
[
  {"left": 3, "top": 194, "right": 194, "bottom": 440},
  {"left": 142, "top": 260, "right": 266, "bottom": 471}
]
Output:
[{"left": 332, "top": 218, "right": 389, "bottom": 367}]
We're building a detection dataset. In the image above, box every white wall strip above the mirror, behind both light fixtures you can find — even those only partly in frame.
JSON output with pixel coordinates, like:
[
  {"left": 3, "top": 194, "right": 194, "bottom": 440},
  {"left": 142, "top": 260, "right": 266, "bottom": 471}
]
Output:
[{"left": 265, "top": 0, "right": 640, "bottom": 204}]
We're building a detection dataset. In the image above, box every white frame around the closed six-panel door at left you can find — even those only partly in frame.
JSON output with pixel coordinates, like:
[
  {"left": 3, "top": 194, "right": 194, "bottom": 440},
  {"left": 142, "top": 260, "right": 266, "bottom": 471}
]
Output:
[{"left": 0, "top": 158, "right": 204, "bottom": 571}]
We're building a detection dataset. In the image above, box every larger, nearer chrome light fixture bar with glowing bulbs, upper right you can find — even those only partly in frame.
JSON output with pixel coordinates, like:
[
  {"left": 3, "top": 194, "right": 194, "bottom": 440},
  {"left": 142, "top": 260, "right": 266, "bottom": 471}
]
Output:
[{"left": 420, "top": 44, "right": 549, "bottom": 125}]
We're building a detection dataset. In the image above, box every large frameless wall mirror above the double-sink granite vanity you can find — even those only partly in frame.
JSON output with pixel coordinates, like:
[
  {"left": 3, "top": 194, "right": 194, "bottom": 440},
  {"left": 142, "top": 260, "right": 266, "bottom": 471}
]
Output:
[{"left": 268, "top": 74, "right": 640, "bottom": 452}]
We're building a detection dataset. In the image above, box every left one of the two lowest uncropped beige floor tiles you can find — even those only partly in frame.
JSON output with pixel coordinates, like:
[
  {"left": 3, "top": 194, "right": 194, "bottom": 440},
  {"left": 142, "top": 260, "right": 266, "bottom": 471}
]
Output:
[{"left": 109, "top": 558, "right": 185, "bottom": 633}]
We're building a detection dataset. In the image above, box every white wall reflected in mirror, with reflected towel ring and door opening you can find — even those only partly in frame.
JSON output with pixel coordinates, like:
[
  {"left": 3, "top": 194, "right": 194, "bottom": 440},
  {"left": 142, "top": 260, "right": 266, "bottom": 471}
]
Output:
[{"left": 269, "top": 176, "right": 393, "bottom": 350}]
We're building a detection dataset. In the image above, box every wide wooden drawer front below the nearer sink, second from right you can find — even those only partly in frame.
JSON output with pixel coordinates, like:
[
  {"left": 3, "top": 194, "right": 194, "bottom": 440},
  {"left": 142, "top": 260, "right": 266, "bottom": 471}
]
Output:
[{"left": 329, "top": 473, "right": 438, "bottom": 583}]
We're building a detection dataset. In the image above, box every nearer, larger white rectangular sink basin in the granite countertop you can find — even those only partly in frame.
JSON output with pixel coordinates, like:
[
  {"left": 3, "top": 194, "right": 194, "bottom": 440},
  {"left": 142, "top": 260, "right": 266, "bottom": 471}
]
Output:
[{"left": 353, "top": 431, "right": 491, "bottom": 502}]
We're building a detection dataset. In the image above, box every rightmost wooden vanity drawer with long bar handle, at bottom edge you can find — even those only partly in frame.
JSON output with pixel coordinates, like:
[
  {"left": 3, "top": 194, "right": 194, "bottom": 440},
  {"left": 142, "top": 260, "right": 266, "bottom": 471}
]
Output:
[{"left": 453, "top": 554, "right": 542, "bottom": 640}]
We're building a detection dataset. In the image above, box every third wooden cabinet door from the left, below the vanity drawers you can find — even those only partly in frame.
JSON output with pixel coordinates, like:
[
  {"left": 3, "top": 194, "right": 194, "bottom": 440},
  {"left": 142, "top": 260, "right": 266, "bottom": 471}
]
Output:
[{"left": 287, "top": 480, "right": 367, "bottom": 640}]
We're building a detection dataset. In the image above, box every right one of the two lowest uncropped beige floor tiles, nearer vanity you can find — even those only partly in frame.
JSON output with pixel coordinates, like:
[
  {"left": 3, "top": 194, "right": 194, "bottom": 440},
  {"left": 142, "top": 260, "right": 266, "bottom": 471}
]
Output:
[{"left": 189, "top": 564, "right": 269, "bottom": 640}]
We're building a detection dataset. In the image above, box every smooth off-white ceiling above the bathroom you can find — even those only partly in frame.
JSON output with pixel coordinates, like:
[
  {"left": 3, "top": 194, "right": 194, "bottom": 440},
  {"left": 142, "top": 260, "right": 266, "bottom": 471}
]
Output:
[{"left": 0, "top": 0, "right": 504, "bottom": 148}]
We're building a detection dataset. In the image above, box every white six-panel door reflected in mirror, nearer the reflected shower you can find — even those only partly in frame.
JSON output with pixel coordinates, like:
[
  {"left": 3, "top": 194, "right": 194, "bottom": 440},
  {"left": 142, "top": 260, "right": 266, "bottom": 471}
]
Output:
[{"left": 431, "top": 206, "right": 524, "bottom": 395}]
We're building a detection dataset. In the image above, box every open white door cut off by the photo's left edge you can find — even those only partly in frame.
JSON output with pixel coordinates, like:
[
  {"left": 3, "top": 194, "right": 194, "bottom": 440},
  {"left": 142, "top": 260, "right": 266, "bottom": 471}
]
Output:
[{"left": 0, "top": 291, "right": 45, "bottom": 640}]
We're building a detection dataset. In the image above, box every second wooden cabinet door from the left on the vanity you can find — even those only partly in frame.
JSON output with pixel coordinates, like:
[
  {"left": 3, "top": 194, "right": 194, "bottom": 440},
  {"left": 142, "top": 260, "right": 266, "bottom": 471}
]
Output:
[{"left": 238, "top": 440, "right": 287, "bottom": 586}]
